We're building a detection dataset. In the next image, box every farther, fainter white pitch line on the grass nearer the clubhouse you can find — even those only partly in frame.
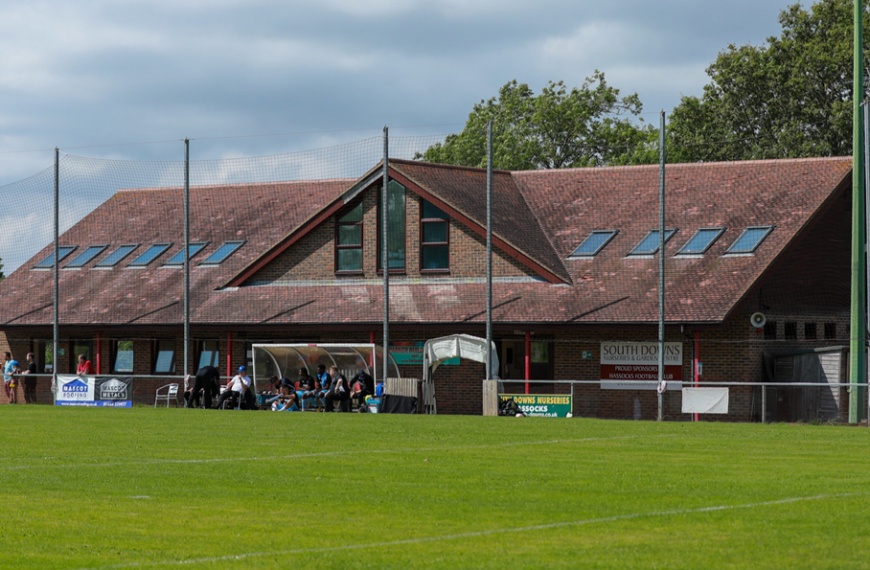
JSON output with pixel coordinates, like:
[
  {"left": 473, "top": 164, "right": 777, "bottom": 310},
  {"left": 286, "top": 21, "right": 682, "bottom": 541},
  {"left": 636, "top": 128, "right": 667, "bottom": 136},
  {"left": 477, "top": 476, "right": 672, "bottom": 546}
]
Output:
[{"left": 0, "top": 434, "right": 675, "bottom": 472}]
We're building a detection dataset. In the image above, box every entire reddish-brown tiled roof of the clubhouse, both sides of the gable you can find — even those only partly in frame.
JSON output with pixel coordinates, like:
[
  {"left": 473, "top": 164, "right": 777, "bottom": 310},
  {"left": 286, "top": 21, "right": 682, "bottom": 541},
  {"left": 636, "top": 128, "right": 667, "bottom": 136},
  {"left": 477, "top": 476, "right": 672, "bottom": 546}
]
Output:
[{"left": 0, "top": 158, "right": 851, "bottom": 327}]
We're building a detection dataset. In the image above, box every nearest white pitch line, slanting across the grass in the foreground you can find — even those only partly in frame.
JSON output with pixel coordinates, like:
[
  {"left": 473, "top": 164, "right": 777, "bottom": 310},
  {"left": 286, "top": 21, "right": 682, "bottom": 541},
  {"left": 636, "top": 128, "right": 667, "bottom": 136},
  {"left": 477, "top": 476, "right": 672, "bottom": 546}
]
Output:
[{"left": 80, "top": 493, "right": 868, "bottom": 570}]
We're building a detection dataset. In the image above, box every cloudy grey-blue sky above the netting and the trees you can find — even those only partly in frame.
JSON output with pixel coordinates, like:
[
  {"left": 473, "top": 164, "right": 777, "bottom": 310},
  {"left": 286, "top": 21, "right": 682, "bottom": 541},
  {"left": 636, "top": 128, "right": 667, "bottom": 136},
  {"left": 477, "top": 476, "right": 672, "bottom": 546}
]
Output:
[{"left": 0, "top": 0, "right": 790, "bottom": 180}]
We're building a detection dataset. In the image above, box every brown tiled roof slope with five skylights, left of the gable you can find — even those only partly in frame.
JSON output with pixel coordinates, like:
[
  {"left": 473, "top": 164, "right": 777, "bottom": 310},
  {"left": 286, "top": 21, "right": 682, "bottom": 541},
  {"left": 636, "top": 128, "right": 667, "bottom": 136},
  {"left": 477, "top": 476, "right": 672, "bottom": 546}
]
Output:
[{"left": 0, "top": 180, "right": 353, "bottom": 325}]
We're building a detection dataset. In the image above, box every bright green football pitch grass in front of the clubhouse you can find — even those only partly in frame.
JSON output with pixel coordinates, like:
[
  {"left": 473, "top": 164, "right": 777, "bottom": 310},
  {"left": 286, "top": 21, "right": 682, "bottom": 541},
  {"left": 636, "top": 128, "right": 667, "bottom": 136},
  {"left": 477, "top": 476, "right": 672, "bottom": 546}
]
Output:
[{"left": 0, "top": 406, "right": 870, "bottom": 569}]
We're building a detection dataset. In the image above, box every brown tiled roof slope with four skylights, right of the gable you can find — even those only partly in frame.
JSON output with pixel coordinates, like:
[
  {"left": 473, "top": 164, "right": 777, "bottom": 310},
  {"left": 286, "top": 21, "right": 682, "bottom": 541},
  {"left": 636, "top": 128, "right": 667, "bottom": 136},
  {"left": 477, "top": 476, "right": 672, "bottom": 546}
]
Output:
[{"left": 513, "top": 158, "right": 851, "bottom": 322}]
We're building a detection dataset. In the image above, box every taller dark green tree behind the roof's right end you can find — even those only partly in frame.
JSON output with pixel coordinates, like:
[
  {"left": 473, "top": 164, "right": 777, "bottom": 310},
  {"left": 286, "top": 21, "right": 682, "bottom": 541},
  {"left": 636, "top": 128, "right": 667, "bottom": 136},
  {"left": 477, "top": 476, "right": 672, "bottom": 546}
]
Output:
[{"left": 668, "top": 0, "right": 868, "bottom": 162}]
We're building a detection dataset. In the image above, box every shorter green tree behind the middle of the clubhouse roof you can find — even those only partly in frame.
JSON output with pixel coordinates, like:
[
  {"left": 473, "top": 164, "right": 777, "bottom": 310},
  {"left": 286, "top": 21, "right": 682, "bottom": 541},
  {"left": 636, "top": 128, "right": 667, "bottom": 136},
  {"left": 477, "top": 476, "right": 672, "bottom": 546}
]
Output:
[{"left": 416, "top": 71, "right": 658, "bottom": 170}]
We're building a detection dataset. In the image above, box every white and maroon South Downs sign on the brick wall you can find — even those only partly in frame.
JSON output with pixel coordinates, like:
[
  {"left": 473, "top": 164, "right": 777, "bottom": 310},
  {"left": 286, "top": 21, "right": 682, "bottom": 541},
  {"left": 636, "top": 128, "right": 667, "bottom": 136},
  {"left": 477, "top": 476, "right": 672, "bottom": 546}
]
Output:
[{"left": 601, "top": 342, "right": 683, "bottom": 390}]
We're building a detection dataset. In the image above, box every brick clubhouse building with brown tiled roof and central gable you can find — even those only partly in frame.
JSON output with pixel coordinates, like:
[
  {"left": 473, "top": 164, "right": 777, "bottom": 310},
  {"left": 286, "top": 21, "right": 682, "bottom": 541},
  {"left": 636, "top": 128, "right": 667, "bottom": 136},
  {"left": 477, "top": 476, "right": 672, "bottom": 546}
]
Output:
[{"left": 0, "top": 158, "right": 851, "bottom": 421}]
